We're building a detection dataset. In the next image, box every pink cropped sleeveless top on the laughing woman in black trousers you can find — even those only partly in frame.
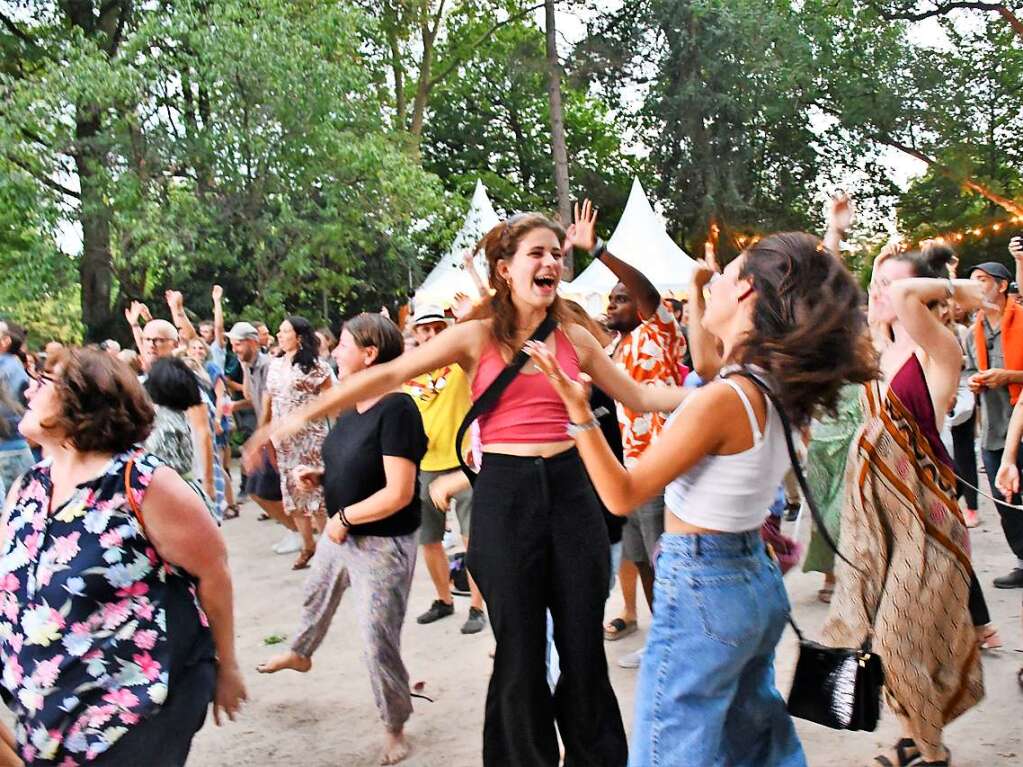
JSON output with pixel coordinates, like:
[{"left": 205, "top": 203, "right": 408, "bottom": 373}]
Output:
[{"left": 473, "top": 328, "right": 579, "bottom": 447}]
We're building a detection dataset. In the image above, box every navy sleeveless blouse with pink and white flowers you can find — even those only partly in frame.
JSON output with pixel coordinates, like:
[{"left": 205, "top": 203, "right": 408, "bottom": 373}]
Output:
[{"left": 0, "top": 452, "right": 212, "bottom": 767}]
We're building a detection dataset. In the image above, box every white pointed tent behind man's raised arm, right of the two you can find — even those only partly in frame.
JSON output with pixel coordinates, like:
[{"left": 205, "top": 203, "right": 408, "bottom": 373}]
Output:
[{"left": 560, "top": 179, "right": 696, "bottom": 314}]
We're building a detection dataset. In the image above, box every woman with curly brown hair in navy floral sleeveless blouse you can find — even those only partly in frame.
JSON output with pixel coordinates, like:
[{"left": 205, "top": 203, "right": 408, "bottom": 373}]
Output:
[{"left": 0, "top": 350, "right": 246, "bottom": 767}]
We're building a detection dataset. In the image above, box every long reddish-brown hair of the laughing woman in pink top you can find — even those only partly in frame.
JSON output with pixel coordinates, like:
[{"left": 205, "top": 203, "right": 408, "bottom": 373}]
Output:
[{"left": 473, "top": 213, "right": 573, "bottom": 353}]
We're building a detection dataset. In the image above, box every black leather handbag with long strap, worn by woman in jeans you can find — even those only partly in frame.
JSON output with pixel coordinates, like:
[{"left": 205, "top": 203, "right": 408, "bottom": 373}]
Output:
[{"left": 726, "top": 368, "right": 885, "bottom": 732}]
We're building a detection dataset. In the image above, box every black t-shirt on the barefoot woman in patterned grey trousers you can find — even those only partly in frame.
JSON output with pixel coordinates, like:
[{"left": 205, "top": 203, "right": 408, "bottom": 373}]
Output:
[{"left": 323, "top": 394, "right": 427, "bottom": 538}]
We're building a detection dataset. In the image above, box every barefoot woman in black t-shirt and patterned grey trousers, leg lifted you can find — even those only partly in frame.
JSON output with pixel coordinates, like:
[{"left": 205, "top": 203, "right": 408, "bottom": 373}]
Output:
[{"left": 257, "top": 314, "right": 427, "bottom": 764}]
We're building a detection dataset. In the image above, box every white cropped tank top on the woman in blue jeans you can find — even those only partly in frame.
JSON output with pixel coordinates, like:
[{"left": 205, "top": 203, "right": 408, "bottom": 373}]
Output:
[{"left": 664, "top": 378, "right": 790, "bottom": 533}]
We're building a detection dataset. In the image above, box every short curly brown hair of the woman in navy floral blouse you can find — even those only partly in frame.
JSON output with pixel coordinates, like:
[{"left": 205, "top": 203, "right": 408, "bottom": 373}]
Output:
[{"left": 40, "top": 349, "right": 154, "bottom": 453}]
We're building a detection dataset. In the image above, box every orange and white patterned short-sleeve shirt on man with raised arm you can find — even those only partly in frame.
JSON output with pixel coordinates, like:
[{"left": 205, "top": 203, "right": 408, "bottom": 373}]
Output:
[{"left": 615, "top": 303, "right": 685, "bottom": 466}]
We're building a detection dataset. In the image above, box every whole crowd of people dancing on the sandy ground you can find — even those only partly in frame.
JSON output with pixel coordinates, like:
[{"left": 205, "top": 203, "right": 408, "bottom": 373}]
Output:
[{"left": 0, "top": 195, "right": 1023, "bottom": 767}]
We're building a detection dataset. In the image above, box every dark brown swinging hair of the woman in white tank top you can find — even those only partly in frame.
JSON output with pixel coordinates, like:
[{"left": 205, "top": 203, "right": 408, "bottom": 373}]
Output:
[{"left": 731, "top": 232, "right": 880, "bottom": 426}]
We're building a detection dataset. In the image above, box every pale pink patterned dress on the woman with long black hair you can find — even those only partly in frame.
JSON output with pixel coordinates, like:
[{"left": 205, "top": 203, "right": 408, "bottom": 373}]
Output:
[{"left": 266, "top": 357, "right": 330, "bottom": 516}]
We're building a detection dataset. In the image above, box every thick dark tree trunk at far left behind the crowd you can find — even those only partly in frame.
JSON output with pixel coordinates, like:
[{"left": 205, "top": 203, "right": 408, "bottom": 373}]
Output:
[{"left": 75, "top": 106, "right": 114, "bottom": 341}]
